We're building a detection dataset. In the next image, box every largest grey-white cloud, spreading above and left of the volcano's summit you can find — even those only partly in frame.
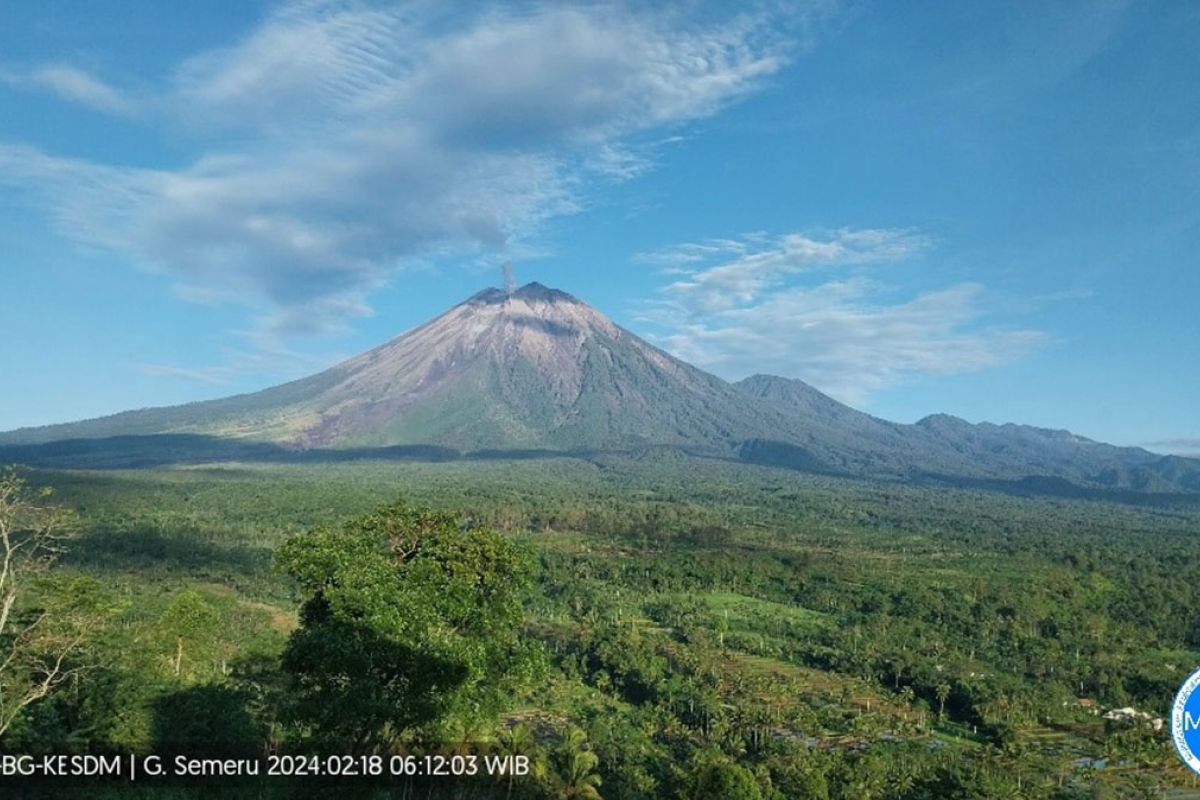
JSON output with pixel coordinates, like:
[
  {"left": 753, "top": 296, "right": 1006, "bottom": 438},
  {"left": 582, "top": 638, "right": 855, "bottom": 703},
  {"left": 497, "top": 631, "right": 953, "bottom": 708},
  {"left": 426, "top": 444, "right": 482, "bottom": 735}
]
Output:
[{"left": 0, "top": 0, "right": 802, "bottom": 352}]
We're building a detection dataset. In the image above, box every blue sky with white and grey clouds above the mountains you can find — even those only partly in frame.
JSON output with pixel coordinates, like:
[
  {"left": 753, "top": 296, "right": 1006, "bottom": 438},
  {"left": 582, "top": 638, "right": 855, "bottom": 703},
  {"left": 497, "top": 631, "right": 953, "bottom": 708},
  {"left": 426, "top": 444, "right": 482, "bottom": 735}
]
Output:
[{"left": 0, "top": 0, "right": 1200, "bottom": 455}]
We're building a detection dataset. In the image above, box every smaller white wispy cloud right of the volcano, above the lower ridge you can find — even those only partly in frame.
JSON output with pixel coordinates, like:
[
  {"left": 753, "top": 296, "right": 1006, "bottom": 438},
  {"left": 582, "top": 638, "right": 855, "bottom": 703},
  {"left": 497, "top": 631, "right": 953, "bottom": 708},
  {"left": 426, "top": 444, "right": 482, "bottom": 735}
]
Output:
[{"left": 642, "top": 229, "right": 1044, "bottom": 405}]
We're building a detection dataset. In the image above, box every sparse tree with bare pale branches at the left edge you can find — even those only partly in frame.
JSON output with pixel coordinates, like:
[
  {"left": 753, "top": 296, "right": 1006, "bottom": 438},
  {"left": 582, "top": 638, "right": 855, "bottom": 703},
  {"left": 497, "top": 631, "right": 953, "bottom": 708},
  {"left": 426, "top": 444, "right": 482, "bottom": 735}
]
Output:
[{"left": 0, "top": 469, "right": 109, "bottom": 735}]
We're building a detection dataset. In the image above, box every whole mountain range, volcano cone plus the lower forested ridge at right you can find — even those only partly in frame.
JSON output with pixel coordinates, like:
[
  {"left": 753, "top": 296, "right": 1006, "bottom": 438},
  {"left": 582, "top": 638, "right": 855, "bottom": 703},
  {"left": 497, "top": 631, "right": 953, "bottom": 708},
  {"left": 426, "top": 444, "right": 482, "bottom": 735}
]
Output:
[{"left": 0, "top": 283, "right": 1200, "bottom": 492}]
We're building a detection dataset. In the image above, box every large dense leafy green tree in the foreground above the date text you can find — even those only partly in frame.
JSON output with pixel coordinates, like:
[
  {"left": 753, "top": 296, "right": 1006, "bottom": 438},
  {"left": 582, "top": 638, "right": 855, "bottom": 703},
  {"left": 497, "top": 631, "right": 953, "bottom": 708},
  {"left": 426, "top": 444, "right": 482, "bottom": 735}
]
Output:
[{"left": 276, "top": 503, "right": 540, "bottom": 752}]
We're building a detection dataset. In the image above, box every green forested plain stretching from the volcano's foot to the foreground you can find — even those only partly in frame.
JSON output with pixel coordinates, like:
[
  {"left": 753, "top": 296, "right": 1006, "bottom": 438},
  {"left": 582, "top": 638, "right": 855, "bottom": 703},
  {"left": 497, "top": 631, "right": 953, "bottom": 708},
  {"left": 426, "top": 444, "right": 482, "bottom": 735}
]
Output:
[{"left": 0, "top": 453, "right": 1200, "bottom": 800}]
